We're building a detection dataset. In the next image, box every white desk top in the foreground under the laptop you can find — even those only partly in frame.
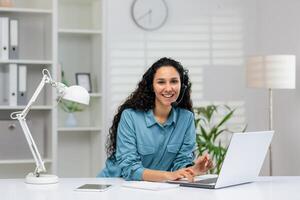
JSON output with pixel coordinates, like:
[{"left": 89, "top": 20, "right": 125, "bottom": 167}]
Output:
[{"left": 0, "top": 177, "right": 300, "bottom": 200}]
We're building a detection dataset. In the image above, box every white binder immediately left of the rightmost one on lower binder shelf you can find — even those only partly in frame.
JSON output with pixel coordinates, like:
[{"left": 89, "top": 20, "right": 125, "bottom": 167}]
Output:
[{"left": 8, "top": 64, "right": 18, "bottom": 106}]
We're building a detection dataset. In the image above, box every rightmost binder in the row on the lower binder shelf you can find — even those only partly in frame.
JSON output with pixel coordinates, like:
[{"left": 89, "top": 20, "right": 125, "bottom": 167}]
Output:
[{"left": 17, "top": 65, "right": 27, "bottom": 105}]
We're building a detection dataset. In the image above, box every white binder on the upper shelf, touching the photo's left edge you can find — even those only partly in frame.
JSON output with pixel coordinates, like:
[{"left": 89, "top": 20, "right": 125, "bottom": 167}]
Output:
[{"left": 0, "top": 17, "right": 9, "bottom": 60}]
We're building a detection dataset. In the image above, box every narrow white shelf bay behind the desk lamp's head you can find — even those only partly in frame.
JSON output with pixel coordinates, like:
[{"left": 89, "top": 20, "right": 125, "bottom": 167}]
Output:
[{"left": 57, "top": 0, "right": 103, "bottom": 177}]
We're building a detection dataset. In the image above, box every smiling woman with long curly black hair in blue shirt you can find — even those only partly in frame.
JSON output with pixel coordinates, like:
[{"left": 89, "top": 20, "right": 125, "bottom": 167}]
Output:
[{"left": 98, "top": 58, "right": 212, "bottom": 181}]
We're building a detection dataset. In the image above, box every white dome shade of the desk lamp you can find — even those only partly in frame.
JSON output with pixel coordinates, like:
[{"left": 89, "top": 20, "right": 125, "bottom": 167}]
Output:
[{"left": 62, "top": 85, "right": 90, "bottom": 105}]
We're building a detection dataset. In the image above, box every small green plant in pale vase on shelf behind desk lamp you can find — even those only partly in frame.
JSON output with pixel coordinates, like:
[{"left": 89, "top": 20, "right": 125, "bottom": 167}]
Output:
[{"left": 59, "top": 70, "right": 84, "bottom": 127}]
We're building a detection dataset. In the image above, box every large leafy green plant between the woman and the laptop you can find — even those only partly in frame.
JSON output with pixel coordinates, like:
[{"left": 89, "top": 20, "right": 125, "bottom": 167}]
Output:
[{"left": 194, "top": 105, "right": 246, "bottom": 174}]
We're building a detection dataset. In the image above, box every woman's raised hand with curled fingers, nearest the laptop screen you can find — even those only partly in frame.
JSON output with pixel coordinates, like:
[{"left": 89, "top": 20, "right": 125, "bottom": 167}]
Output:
[{"left": 190, "top": 154, "right": 213, "bottom": 176}]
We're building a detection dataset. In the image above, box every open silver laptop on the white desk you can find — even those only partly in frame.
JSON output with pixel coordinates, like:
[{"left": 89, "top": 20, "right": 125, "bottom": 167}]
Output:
[{"left": 168, "top": 131, "right": 274, "bottom": 189}]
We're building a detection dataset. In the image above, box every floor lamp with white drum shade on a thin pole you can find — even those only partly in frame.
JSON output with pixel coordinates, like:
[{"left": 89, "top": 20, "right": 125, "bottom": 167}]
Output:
[{"left": 246, "top": 55, "right": 296, "bottom": 176}]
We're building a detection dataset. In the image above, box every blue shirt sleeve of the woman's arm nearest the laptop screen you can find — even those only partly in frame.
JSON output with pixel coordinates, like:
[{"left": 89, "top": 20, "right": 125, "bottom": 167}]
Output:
[{"left": 171, "top": 114, "right": 196, "bottom": 171}]
